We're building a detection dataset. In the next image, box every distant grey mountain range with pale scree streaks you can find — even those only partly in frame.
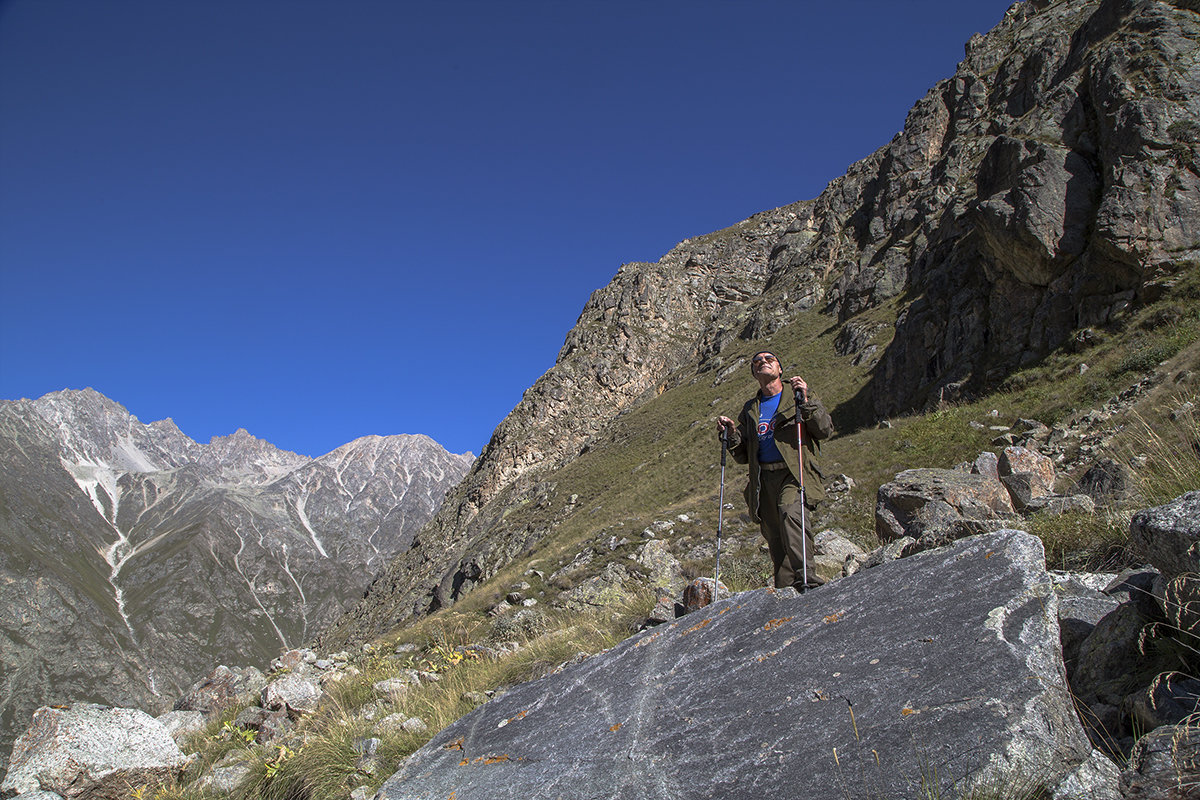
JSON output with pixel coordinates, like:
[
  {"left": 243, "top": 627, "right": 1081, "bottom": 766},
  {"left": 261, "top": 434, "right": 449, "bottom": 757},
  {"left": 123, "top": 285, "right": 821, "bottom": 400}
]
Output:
[{"left": 0, "top": 390, "right": 472, "bottom": 777}]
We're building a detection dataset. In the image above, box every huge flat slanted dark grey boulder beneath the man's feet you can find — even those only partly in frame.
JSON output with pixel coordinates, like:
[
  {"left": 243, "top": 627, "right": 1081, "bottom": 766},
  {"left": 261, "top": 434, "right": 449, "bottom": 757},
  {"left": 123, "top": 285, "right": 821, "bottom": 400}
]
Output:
[{"left": 379, "top": 531, "right": 1092, "bottom": 800}]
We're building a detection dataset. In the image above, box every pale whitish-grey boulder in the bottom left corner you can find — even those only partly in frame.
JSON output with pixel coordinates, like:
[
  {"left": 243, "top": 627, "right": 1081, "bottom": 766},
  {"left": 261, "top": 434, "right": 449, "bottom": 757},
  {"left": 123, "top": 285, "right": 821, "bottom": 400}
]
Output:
[{"left": 0, "top": 703, "right": 187, "bottom": 800}]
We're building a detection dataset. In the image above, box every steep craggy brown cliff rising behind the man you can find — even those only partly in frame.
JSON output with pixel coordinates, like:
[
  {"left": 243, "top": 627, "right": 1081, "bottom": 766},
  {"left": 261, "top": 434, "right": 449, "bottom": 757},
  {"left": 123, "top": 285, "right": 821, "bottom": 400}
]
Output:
[{"left": 325, "top": 0, "right": 1200, "bottom": 643}]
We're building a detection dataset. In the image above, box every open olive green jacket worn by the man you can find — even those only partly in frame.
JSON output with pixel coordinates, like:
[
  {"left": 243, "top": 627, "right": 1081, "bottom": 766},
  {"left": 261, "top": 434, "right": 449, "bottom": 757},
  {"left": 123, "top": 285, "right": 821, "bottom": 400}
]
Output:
[{"left": 728, "top": 393, "right": 833, "bottom": 522}]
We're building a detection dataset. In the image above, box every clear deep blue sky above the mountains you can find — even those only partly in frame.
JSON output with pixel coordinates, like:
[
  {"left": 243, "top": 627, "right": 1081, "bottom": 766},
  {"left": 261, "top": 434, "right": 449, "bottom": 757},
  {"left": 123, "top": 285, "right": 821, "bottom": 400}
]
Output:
[{"left": 0, "top": 0, "right": 1009, "bottom": 456}]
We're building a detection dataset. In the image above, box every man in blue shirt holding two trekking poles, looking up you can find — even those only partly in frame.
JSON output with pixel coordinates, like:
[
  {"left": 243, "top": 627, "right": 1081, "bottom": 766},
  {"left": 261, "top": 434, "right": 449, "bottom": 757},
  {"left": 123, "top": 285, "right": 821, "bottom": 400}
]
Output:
[{"left": 718, "top": 350, "right": 833, "bottom": 591}]
